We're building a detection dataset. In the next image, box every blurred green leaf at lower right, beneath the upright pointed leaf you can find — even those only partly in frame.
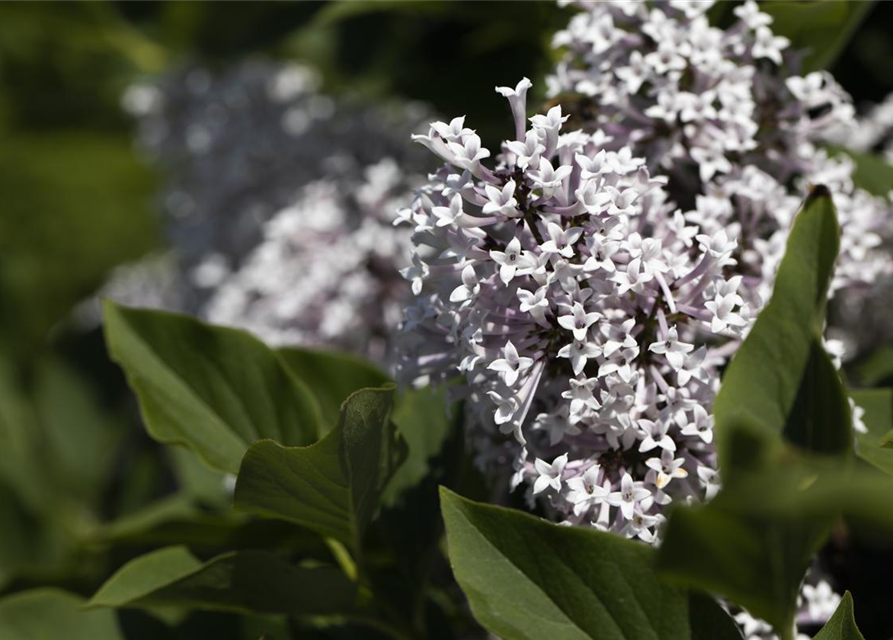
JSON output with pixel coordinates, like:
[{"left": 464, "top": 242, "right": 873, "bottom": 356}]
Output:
[{"left": 657, "top": 456, "right": 893, "bottom": 632}]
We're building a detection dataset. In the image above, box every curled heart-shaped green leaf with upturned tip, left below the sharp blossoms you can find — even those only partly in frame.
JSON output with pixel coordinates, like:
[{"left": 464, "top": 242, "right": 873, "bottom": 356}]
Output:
[{"left": 235, "top": 386, "right": 406, "bottom": 550}]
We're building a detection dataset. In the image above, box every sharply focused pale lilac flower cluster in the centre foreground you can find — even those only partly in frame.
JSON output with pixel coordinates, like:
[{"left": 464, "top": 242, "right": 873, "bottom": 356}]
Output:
[{"left": 399, "top": 79, "right": 752, "bottom": 542}]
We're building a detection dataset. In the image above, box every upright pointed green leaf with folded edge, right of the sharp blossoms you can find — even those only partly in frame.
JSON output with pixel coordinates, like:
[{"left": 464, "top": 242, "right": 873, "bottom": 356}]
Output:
[{"left": 714, "top": 186, "right": 851, "bottom": 470}]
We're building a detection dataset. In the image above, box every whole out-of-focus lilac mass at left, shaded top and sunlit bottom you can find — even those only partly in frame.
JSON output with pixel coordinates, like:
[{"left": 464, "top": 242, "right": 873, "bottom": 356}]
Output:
[{"left": 112, "top": 60, "right": 426, "bottom": 362}]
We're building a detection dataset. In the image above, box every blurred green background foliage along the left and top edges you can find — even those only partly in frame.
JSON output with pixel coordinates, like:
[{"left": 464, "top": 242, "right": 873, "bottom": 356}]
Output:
[{"left": 0, "top": 0, "right": 893, "bottom": 638}]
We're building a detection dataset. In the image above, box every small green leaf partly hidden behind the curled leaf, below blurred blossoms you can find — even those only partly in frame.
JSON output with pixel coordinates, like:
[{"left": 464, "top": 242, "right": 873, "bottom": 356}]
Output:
[{"left": 276, "top": 347, "right": 390, "bottom": 435}]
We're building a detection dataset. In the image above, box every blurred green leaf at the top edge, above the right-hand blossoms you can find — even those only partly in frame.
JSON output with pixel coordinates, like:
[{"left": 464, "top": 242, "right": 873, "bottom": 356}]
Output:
[{"left": 760, "top": 0, "right": 874, "bottom": 73}]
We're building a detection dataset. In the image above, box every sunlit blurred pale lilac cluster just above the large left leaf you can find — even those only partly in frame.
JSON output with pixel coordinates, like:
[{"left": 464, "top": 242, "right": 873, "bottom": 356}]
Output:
[{"left": 205, "top": 159, "right": 410, "bottom": 362}]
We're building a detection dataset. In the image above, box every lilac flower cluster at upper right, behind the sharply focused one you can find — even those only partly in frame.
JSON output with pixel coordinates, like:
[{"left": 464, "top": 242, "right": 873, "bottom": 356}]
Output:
[{"left": 549, "top": 0, "right": 893, "bottom": 306}]
